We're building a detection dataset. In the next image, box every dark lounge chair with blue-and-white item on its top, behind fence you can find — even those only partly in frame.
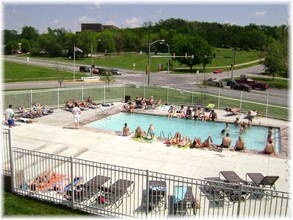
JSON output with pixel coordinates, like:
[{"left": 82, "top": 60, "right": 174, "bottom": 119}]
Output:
[{"left": 148, "top": 180, "right": 167, "bottom": 211}]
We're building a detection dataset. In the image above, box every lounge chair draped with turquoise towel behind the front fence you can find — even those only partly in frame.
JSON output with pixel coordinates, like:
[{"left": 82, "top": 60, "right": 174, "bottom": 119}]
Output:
[{"left": 173, "top": 186, "right": 196, "bottom": 215}]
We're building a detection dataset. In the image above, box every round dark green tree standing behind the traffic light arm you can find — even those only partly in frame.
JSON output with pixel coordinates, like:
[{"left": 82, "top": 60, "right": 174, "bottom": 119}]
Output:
[{"left": 172, "top": 34, "right": 212, "bottom": 70}]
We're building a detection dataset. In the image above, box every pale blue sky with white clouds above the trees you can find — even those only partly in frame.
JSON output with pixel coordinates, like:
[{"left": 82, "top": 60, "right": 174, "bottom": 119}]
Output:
[{"left": 1, "top": 0, "right": 291, "bottom": 34}]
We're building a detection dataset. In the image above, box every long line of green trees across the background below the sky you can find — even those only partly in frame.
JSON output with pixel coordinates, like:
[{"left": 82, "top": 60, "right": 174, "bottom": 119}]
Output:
[{"left": 3, "top": 18, "right": 289, "bottom": 76}]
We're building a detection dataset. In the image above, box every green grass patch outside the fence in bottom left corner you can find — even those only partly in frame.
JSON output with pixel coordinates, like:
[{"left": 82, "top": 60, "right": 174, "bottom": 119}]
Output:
[{"left": 2, "top": 191, "right": 90, "bottom": 217}]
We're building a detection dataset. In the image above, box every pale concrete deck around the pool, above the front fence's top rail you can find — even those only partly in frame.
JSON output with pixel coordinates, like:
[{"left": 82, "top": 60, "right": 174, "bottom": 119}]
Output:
[{"left": 12, "top": 103, "right": 291, "bottom": 192}]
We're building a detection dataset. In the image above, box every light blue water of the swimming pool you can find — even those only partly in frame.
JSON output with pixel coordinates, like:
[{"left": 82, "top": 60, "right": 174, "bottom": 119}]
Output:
[{"left": 86, "top": 112, "right": 280, "bottom": 152}]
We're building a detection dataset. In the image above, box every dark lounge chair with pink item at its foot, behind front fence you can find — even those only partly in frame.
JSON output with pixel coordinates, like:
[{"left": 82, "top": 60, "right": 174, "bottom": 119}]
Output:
[{"left": 96, "top": 179, "right": 134, "bottom": 208}]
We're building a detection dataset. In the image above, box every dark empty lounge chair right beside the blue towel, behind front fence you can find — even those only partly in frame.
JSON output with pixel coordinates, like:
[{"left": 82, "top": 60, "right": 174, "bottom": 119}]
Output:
[{"left": 66, "top": 175, "right": 111, "bottom": 202}]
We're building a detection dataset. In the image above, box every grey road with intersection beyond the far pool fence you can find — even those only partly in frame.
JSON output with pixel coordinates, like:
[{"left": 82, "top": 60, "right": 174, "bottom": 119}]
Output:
[{"left": 2, "top": 56, "right": 289, "bottom": 106}]
